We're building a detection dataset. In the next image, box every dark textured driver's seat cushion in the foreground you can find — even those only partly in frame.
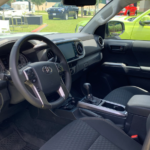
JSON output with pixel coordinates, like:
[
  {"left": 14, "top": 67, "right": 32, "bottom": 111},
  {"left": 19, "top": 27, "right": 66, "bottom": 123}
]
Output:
[{"left": 40, "top": 117, "right": 142, "bottom": 150}]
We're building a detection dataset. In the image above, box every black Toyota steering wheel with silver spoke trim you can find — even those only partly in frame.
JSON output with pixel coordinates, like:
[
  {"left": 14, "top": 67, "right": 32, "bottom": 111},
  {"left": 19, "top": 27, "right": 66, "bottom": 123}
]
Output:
[{"left": 9, "top": 35, "right": 71, "bottom": 109}]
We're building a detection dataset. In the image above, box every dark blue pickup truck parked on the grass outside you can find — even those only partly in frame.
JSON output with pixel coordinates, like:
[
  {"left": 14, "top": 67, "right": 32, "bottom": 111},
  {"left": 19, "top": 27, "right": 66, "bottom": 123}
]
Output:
[{"left": 47, "top": 3, "right": 79, "bottom": 20}]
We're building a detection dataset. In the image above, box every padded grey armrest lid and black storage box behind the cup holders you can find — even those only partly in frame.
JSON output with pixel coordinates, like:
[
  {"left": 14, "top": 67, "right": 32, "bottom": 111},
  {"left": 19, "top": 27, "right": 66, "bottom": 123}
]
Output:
[{"left": 125, "top": 95, "right": 150, "bottom": 141}]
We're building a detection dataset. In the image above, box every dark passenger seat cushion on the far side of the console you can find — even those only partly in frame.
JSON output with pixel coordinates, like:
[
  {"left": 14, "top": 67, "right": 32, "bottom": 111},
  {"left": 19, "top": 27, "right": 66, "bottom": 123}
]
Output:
[{"left": 104, "top": 86, "right": 150, "bottom": 106}]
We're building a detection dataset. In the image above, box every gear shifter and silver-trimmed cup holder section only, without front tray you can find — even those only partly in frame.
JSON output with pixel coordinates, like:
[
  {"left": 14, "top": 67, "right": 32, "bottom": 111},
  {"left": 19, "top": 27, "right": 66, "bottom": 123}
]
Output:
[{"left": 77, "top": 83, "right": 128, "bottom": 125}]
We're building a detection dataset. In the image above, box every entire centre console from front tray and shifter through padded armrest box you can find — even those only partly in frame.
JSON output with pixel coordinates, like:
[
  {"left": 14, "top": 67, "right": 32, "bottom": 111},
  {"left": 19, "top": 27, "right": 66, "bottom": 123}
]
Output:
[{"left": 55, "top": 83, "right": 150, "bottom": 143}]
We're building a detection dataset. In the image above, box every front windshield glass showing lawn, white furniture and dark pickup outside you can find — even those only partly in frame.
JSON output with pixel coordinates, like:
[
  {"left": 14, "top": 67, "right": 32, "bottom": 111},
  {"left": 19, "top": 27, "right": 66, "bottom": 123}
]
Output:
[{"left": 0, "top": 0, "right": 110, "bottom": 38}]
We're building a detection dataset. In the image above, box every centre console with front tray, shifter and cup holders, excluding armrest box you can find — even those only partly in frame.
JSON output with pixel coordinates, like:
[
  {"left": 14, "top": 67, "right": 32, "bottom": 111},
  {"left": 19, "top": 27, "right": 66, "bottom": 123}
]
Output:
[{"left": 57, "top": 83, "right": 128, "bottom": 128}]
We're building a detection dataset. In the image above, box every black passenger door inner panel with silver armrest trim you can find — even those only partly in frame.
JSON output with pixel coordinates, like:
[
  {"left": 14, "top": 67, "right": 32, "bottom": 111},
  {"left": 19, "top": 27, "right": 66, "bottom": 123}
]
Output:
[{"left": 100, "top": 39, "right": 150, "bottom": 94}]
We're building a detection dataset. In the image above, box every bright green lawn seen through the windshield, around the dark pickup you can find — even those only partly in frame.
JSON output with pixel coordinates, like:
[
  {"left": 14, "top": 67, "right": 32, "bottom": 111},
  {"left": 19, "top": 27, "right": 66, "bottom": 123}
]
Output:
[{"left": 11, "top": 12, "right": 92, "bottom": 33}]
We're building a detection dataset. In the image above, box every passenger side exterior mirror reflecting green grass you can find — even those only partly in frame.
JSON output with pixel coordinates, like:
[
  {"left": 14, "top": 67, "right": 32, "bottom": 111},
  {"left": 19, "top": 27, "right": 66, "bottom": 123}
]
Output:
[{"left": 106, "top": 21, "right": 125, "bottom": 38}]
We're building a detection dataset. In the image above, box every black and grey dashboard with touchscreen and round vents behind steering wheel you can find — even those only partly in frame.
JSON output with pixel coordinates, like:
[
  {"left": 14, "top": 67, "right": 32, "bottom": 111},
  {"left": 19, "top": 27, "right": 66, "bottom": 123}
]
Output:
[{"left": 0, "top": 33, "right": 104, "bottom": 104}]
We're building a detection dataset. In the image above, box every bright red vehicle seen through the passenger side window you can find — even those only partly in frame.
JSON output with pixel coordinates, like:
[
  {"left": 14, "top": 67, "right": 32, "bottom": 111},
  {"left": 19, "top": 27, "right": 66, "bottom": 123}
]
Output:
[{"left": 118, "top": 4, "right": 137, "bottom": 16}]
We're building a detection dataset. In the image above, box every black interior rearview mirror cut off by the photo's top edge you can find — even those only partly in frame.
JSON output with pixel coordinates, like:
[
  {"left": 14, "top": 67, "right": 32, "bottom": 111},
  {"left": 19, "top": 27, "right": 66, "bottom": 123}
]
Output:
[{"left": 62, "top": 0, "right": 96, "bottom": 6}]
